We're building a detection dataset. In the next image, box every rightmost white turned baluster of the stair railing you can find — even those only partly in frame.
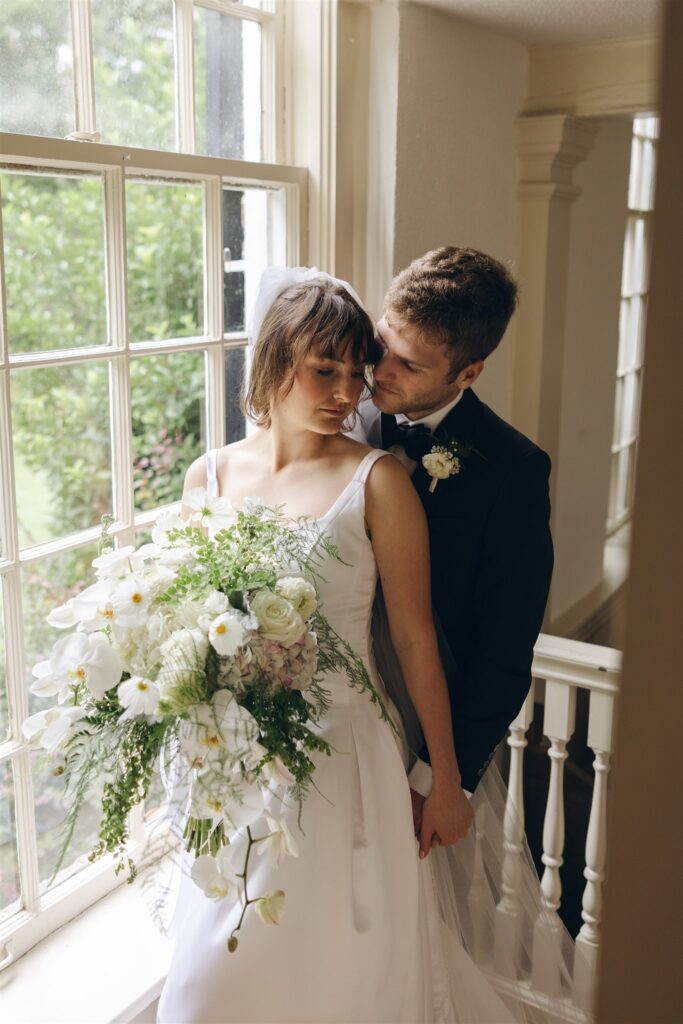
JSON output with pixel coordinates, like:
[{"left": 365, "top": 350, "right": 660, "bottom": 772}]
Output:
[{"left": 573, "top": 692, "right": 614, "bottom": 1012}]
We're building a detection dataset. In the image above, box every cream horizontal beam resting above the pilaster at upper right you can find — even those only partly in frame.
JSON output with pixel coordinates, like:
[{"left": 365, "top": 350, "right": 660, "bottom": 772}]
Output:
[{"left": 524, "top": 35, "right": 659, "bottom": 117}]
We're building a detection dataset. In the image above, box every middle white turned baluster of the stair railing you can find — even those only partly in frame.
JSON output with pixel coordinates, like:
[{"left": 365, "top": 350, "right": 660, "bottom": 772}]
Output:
[{"left": 531, "top": 681, "right": 577, "bottom": 995}]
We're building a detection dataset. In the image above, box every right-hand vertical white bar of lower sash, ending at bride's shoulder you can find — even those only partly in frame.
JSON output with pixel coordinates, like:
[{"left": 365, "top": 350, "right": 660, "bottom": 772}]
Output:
[{"left": 204, "top": 177, "right": 225, "bottom": 449}]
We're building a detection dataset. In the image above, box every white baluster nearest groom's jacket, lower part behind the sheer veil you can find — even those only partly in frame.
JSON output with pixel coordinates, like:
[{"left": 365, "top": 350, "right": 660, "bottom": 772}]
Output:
[{"left": 494, "top": 683, "right": 533, "bottom": 978}]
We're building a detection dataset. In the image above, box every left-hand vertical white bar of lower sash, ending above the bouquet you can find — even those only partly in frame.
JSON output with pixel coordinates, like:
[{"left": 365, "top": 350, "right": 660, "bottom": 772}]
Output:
[{"left": 104, "top": 168, "right": 134, "bottom": 544}]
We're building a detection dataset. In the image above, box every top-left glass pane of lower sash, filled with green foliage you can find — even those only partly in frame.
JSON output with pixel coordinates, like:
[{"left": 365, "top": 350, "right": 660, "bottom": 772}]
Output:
[{"left": 0, "top": 174, "right": 106, "bottom": 352}]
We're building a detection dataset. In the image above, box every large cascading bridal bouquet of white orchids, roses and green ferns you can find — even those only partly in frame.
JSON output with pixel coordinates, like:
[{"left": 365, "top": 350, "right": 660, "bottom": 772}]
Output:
[{"left": 24, "top": 488, "right": 386, "bottom": 950}]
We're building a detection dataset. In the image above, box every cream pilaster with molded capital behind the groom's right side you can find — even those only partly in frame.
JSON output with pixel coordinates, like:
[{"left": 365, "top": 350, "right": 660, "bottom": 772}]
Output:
[{"left": 512, "top": 114, "right": 596, "bottom": 487}]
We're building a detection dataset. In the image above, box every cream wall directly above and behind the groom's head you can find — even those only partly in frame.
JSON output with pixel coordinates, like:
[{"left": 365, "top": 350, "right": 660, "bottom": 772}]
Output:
[{"left": 393, "top": 3, "right": 527, "bottom": 417}]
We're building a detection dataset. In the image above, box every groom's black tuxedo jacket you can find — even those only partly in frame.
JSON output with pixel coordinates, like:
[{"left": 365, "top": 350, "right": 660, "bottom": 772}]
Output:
[{"left": 370, "top": 389, "right": 553, "bottom": 791}]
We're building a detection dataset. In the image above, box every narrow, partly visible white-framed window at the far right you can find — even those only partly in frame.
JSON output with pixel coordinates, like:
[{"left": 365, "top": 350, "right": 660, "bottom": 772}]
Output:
[{"left": 607, "top": 117, "right": 658, "bottom": 534}]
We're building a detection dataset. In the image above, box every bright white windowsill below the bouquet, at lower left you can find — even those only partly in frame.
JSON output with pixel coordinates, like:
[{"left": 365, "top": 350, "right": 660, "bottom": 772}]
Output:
[{"left": 0, "top": 881, "right": 171, "bottom": 1024}]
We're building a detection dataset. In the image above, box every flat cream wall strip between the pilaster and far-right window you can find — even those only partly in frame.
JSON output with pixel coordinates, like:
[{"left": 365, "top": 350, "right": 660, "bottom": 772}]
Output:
[{"left": 551, "top": 117, "right": 631, "bottom": 620}]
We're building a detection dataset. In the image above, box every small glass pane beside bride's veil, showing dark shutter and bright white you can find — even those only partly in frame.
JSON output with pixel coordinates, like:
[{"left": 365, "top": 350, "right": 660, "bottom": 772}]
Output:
[{"left": 223, "top": 187, "right": 287, "bottom": 333}]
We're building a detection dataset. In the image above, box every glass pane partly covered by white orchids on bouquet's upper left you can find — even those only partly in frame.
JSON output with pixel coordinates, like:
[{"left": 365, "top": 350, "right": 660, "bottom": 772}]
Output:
[{"left": 22, "top": 544, "right": 97, "bottom": 715}]
